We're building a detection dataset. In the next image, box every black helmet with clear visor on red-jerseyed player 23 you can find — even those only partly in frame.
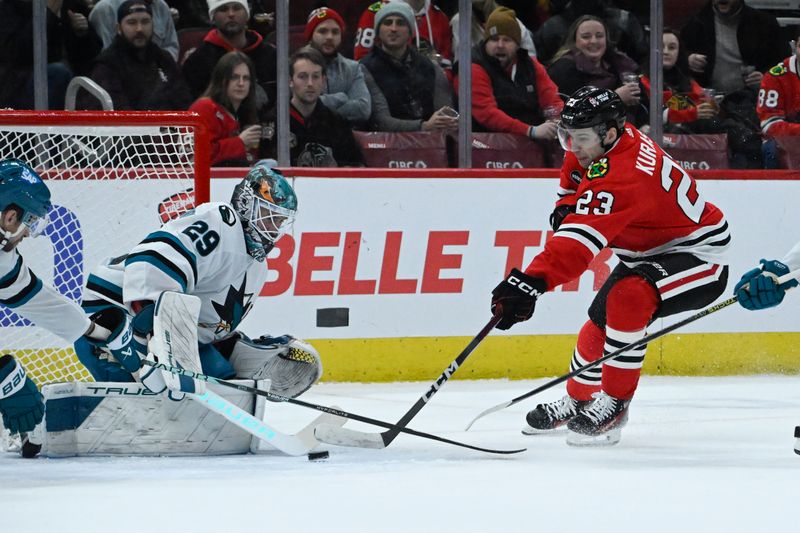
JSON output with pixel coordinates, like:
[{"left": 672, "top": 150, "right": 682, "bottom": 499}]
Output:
[{"left": 558, "top": 85, "right": 627, "bottom": 152}]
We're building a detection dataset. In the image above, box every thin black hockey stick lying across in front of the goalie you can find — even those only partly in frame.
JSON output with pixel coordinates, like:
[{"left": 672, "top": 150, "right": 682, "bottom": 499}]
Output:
[{"left": 142, "top": 359, "right": 526, "bottom": 455}]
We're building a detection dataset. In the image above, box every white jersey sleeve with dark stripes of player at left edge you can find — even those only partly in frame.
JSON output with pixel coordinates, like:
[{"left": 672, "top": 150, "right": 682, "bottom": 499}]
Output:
[{"left": 0, "top": 246, "right": 91, "bottom": 342}]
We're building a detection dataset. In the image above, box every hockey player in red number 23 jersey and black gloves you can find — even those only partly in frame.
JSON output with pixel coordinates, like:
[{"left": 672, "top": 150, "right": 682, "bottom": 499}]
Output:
[{"left": 492, "top": 87, "right": 730, "bottom": 445}]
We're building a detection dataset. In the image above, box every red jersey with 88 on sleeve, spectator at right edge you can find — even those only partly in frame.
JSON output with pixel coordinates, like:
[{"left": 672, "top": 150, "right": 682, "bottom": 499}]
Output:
[{"left": 756, "top": 56, "right": 800, "bottom": 137}]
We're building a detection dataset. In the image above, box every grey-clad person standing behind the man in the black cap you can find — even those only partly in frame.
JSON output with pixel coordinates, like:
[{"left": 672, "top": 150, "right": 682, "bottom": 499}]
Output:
[{"left": 89, "top": 0, "right": 178, "bottom": 61}]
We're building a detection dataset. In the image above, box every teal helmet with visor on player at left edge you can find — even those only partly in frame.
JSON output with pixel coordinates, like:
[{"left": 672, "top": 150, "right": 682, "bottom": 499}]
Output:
[{"left": 0, "top": 159, "right": 51, "bottom": 246}]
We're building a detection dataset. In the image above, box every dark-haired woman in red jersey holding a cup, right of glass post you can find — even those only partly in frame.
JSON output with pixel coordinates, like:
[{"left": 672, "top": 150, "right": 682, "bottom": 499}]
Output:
[{"left": 639, "top": 28, "right": 719, "bottom": 133}]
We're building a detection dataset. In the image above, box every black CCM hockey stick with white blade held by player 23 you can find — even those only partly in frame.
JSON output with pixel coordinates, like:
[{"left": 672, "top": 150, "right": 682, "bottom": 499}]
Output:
[{"left": 314, "top": 315, "right": 502, "bottom": 449}]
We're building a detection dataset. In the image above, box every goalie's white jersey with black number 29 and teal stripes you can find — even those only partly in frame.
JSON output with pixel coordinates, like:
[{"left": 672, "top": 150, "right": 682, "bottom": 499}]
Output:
[{"left": 83, "top": 202, "right": 267, "bottom": 343}]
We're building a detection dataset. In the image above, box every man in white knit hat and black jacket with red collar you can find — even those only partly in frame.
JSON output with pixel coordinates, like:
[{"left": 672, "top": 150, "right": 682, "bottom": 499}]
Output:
[{"left": 182, "top": 0, "right": 277, "bottom": 114}]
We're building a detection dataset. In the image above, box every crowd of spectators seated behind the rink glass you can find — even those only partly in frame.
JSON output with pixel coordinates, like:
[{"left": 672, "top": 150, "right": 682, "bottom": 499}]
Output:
[{"left": 0, "top": 0, "right": 800, "bottom": 168}]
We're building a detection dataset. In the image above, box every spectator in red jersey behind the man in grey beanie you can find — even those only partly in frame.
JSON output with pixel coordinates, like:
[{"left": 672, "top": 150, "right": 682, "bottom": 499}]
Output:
[{"left": 353, "top": 0, "right": 453, "bottom": 68}]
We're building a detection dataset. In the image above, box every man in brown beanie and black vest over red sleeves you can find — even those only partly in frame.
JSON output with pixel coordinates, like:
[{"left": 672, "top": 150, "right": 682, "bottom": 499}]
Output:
[{"left": 456, "top": 7, "right": 564, "bottom": 141}]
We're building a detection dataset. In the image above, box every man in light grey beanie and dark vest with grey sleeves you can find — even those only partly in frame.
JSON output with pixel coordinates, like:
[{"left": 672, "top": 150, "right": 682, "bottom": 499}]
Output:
[{"left": 361, "top": 1, "right": 458, "bottom": 132}]
